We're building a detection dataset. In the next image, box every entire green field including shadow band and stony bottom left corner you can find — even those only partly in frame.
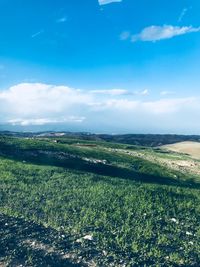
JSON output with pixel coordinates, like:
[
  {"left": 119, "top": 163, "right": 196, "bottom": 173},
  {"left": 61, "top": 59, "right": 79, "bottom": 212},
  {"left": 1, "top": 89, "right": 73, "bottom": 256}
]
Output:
[{"left": 0, "top": 136, "right": 200, "bottom": 267}]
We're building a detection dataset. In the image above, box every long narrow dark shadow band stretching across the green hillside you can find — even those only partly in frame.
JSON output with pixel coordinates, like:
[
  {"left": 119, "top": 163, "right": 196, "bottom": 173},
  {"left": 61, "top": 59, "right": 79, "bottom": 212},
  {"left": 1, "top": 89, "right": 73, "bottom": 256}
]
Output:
[{"left": 0, "top": 143, "right": 200, "bottom": 188}]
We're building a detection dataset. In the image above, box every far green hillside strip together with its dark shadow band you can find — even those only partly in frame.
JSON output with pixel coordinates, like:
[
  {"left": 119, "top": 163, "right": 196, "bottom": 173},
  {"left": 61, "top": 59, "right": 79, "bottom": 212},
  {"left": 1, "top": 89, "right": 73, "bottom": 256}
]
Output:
[{"left": 0, "top": 138, "right": 195, "bottom": 187}]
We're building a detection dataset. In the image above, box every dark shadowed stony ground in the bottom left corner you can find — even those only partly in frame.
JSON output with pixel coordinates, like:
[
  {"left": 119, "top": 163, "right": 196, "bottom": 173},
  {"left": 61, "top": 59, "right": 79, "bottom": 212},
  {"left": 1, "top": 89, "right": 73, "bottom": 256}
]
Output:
[{"left": 0, "top": 214, "right": 86, "bottom": 267}]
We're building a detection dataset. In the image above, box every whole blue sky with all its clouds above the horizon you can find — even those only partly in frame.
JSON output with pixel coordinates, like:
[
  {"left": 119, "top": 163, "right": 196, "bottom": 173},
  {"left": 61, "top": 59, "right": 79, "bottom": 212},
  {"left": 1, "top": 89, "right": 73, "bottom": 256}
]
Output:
[{"left": 0, "top": 0, "right": 200, "bottom": 134}]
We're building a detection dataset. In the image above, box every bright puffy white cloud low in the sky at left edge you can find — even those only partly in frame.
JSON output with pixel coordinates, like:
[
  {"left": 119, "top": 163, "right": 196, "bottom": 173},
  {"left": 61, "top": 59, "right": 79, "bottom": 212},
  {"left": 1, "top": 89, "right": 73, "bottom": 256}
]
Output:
[{"left": 0, "top": 83, "right": 91, "bottom": 124}]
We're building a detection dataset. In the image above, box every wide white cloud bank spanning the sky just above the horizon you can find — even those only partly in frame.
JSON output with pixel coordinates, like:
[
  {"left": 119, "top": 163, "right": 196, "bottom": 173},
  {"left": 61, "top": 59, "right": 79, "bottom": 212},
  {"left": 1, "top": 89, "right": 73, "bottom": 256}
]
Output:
[{"left": 0, "top": 83, "right": 200, "bottom": 132}]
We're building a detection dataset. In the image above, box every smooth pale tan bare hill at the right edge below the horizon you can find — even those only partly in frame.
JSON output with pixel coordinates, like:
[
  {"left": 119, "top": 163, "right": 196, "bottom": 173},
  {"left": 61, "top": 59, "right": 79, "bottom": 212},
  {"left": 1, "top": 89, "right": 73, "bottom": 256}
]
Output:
[{"left": 162, "top": 141, "right": 200, "bottom": 159}]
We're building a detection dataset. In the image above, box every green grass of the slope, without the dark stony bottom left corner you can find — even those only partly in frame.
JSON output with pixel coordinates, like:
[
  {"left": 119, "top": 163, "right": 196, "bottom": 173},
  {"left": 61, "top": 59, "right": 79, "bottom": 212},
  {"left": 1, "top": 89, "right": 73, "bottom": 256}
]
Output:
[{"left": 0, "top": 138, "right": 200, "bottom": 266}]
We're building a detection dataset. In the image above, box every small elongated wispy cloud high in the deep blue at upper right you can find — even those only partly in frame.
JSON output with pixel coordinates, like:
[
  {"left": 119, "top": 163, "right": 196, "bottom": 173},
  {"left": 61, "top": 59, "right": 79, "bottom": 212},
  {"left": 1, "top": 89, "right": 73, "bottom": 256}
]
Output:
[{"left": 120, "top": 25, "right": 200, "bottom": 42}]
